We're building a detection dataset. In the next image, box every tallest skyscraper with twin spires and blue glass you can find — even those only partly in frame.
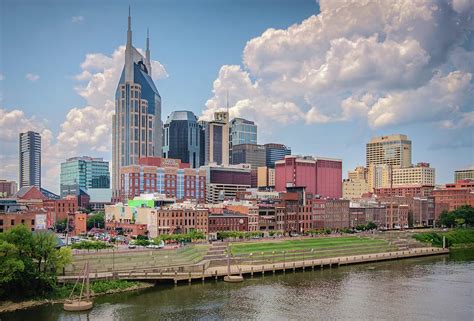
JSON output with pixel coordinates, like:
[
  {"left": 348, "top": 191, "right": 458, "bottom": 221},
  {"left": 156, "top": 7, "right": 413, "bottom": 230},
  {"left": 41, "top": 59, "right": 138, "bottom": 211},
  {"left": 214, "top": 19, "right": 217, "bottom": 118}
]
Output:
[{"left": 112, "top": 8, "right": 163, "bottom": 197}]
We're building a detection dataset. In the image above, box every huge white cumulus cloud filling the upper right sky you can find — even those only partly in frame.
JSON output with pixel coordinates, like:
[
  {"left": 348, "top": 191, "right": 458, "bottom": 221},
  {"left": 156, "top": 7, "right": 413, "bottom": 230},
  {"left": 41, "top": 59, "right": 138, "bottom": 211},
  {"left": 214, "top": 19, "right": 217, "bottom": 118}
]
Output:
[{"left": 202, "top": 0, "right": 474, "bottom": 128}]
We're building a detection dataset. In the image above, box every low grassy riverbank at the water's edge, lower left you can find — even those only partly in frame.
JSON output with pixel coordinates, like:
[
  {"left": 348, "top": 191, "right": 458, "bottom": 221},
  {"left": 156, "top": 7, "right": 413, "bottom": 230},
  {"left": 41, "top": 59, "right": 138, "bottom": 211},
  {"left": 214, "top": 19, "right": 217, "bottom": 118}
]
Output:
[{"left": 0, "top": 281, "right": 155, "bottom": 314}]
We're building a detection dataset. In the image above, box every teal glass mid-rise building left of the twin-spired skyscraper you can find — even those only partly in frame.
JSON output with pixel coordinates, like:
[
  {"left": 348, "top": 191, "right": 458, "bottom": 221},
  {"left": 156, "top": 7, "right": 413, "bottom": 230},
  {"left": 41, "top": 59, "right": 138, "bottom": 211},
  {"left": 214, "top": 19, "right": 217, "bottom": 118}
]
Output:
[{"left": 60, "top": 156, "right": 110, "bottom": 197}]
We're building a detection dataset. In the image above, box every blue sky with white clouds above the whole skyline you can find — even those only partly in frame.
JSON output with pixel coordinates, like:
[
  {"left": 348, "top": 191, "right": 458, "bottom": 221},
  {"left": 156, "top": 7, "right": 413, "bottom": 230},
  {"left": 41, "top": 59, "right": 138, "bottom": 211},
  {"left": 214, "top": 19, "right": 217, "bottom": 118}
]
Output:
[{"left": 0, "top": 0, "right": 474, "bottom": 191}]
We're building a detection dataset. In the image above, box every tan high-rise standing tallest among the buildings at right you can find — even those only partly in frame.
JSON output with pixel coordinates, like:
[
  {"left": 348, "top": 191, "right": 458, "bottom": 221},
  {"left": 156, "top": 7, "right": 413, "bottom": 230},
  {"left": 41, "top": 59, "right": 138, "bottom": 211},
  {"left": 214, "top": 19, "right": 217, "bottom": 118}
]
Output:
[{"left": 366, "top": 134, "right": 412, "bottom": 168}]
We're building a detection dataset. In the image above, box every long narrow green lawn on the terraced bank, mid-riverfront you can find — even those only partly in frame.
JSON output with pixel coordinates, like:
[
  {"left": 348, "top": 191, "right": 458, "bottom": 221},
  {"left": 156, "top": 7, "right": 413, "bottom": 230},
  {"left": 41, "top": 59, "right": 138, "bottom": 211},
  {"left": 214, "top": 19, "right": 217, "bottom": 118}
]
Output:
[{"left": 231, "top": 237, "right": 388, "bottom": 255}]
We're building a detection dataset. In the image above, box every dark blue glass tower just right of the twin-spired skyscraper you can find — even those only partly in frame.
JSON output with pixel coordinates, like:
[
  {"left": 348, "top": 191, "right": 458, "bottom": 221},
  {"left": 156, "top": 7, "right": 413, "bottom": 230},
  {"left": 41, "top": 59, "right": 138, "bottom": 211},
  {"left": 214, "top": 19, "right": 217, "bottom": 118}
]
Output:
[{"left": 163, "top": 110, "right": 202, "bottom": 168}]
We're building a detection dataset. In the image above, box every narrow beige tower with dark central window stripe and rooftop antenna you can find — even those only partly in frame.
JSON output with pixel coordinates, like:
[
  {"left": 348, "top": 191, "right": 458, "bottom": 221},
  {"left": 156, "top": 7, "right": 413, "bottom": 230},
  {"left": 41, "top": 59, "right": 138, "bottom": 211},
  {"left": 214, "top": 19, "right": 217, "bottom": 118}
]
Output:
[{"left": 201, "top": 112, "right": 229, "bottom": 165}]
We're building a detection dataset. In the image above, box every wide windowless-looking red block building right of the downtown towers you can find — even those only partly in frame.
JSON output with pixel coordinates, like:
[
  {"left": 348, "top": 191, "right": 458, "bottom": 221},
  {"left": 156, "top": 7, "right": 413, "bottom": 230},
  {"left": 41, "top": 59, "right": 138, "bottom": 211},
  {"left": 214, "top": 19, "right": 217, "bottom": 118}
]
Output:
[{"left": 275, "top": 156, "right": 342, "bottom": 198}]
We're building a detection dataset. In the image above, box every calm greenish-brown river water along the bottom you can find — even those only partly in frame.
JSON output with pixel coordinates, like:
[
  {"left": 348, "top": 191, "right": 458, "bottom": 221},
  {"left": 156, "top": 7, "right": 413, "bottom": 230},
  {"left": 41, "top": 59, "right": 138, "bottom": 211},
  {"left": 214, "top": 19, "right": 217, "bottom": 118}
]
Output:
[{"left": 0, "top": 249, "right": 474, "bottom": 321}]
